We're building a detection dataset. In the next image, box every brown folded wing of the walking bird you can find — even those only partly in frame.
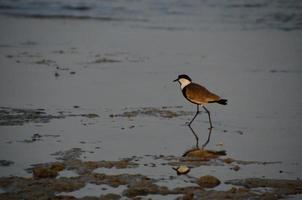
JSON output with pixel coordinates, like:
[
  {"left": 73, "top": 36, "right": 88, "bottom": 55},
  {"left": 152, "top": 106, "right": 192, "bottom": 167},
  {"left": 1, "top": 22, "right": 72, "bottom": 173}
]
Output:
[{"left": 183, "top": 83, "right": 220, "bottom": 104}]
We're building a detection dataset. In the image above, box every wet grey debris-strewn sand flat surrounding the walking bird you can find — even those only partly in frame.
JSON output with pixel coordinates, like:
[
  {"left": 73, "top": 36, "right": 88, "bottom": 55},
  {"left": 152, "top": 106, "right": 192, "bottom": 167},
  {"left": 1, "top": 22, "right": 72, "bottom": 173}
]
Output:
[{"left": 0, "top": 16, "right": 302, "bottom": 199}]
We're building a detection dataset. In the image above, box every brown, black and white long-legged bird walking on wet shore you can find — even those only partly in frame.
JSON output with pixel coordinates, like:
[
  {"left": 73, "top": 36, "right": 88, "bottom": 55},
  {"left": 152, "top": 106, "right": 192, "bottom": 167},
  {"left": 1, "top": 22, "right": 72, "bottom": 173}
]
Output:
[{"left": 174, "top": 74, "right": 228, "bottom": 129}]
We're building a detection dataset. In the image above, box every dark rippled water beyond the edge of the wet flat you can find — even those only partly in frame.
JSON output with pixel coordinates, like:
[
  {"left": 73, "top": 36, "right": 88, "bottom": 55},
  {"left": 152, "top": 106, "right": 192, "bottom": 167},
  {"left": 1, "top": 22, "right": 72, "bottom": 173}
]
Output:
[{"left": 0, "top": 0, "right": 302, "bottom": 31}]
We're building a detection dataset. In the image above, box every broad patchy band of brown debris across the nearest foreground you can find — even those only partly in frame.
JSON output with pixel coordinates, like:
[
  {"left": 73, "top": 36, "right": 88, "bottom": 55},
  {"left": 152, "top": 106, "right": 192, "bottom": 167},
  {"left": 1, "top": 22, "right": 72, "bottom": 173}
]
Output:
[{"left": 0, "top": 154, "right": 302, "bottom": 200}]
